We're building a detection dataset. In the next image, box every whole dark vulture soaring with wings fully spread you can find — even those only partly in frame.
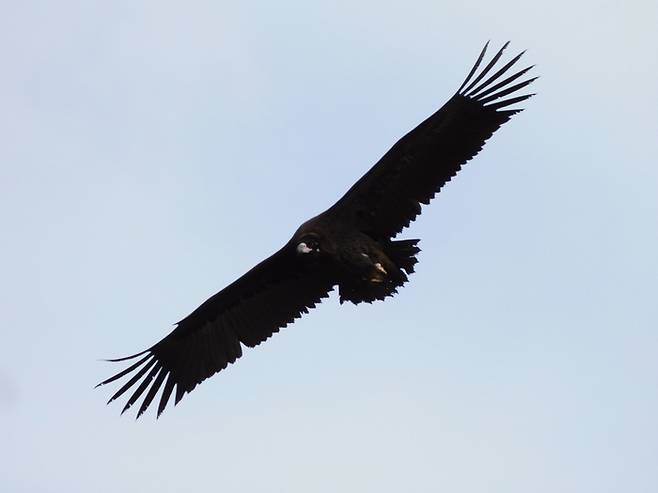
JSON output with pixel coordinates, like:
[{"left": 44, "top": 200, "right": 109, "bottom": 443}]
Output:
[{"left": 98, "top": 42, "right": 536, "bottom": 417}]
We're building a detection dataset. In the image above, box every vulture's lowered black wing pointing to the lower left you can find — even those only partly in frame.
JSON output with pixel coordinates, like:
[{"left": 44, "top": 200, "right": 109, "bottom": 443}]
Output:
[{"left": 98, "top": 243, "right": 334, "bottom": 417}]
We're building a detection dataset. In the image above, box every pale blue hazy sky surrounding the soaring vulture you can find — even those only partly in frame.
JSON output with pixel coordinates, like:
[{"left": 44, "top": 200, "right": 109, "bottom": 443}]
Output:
[{"left": 0, "top": 0, "right": 658, "bottom": 493}]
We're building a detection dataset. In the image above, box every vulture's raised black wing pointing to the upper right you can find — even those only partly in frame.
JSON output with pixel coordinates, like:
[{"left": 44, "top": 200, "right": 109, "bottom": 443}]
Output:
[{"left": 328, "top": 42, "right": 536, "bottom": 240}]
